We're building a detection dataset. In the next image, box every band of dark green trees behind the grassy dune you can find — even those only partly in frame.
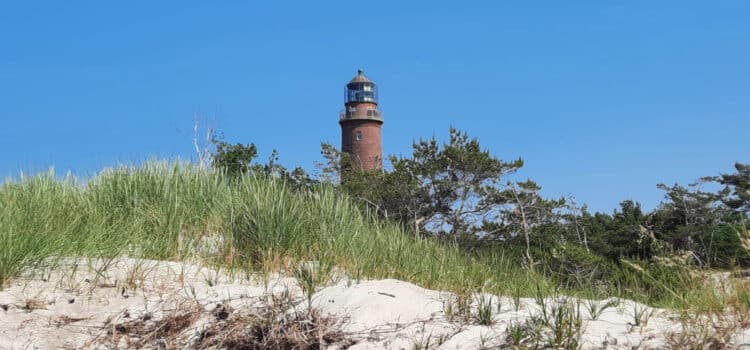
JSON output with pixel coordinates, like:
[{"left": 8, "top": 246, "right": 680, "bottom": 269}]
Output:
[{"left": 207, "top": 128, "right": 750, "bottom": 278}]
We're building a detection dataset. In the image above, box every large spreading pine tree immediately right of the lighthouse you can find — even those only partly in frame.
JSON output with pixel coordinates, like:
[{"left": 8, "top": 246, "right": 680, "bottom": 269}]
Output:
[{"left": 343, "top": 128, "right": 523, "bottom": 241}]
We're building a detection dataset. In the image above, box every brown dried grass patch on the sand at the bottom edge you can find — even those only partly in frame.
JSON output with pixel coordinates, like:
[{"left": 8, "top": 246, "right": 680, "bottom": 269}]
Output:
[{"left": 89, "top": 296, "right": 353, "bottom": 350}]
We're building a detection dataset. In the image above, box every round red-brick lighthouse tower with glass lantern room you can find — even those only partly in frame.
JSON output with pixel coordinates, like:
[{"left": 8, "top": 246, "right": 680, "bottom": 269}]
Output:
[{"left": 339, "top": 70, "right": 383, "bottom": 170}]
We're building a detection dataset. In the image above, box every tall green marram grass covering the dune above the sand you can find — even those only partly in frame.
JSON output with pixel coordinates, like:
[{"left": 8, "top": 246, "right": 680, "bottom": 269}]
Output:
[{"left": 0, "top": 162, "right": 740, "bottom": 306}]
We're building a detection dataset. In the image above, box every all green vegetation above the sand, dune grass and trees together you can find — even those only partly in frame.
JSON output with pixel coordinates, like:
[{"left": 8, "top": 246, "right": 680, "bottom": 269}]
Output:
[{"left": 5, "top": 121, "right": 750, "bottom": 319}]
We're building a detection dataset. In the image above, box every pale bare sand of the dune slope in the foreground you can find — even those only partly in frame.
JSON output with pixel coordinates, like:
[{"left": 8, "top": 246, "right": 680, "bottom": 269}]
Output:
[{"left": 0, "top": 259, "right": 750, "bottom": 349}]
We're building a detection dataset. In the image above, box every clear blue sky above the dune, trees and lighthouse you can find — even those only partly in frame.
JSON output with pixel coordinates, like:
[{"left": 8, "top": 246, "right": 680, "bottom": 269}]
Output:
[{"left": 0, "top": 0, "right": 750, "bottom": 211}]
